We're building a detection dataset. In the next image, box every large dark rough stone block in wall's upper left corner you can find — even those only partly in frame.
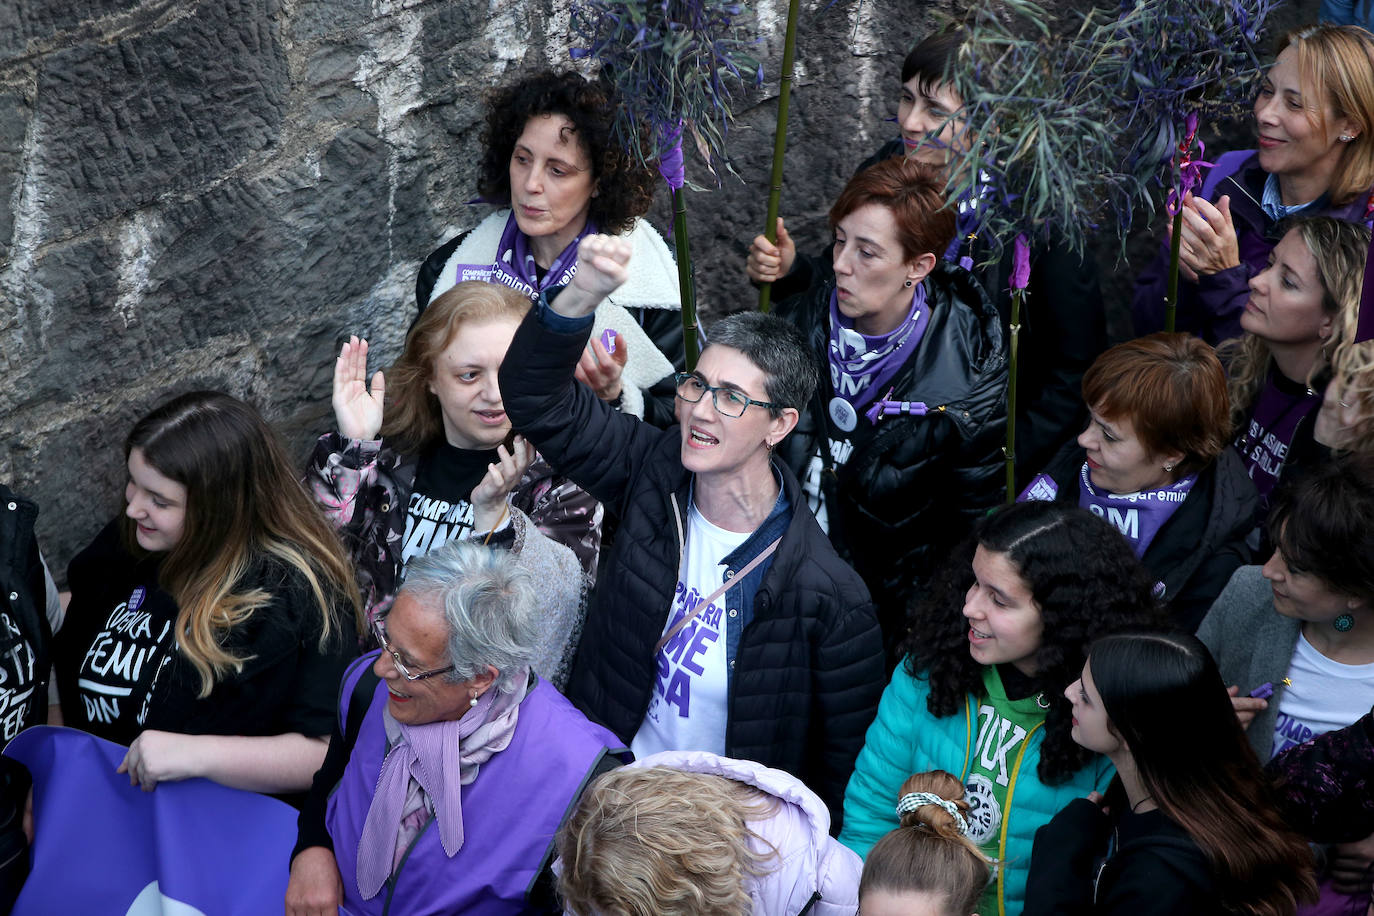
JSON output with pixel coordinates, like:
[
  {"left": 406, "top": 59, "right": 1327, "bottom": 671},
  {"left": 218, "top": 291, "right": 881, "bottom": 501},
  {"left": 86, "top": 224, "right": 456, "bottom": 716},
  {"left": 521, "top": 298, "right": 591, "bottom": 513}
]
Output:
[{"left": 34, "top": 0, "right": 287, "bottom": 236}]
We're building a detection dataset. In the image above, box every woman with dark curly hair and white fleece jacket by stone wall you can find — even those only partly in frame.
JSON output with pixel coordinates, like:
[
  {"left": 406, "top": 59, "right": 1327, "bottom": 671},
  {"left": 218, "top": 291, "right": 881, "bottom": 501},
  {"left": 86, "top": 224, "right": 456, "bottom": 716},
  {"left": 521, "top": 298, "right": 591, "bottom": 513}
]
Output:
[{"left": 415, "top": 70, "right": 683, "bottom": 422}]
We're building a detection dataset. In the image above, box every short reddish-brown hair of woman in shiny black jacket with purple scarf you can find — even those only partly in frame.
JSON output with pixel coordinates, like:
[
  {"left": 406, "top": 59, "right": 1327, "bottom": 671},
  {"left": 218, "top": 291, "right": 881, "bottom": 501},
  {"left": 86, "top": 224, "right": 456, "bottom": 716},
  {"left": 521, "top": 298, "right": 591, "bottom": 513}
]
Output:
[{"left": 830, "top": 157, "right": 955, "bottom": 261}]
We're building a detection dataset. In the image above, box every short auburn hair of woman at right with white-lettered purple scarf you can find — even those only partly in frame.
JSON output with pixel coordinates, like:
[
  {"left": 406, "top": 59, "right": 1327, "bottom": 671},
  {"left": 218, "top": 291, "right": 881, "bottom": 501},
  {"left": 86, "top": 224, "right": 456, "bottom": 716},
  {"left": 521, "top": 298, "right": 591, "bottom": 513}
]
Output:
[{"left": 1083, "top": 334, "right": 1231, "bottom": 477}]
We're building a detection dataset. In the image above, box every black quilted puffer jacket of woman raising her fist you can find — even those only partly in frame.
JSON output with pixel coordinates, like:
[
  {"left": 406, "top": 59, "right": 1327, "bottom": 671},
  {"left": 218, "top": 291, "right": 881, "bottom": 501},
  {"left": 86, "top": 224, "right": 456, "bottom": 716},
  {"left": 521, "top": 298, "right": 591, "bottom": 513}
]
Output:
[{"left": 500, "top": 308, "right": 883, "bottom": 831}]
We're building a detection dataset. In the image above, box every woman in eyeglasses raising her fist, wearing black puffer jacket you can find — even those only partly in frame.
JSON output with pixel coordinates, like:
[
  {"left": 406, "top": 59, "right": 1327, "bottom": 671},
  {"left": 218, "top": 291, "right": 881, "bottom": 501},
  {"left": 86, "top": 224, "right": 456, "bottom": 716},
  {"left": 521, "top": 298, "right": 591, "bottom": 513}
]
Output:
[{"left": 500, "top": 236, "right": 882, "bottom": 816}]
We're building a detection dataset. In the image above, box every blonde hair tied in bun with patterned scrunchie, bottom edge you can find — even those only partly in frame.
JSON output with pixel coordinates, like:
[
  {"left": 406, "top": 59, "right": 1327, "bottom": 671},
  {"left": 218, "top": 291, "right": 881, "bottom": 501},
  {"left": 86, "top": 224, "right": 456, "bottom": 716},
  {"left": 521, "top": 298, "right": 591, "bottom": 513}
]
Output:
[{"left": 859, "top": 769, "right": 992, "bottom": 916}]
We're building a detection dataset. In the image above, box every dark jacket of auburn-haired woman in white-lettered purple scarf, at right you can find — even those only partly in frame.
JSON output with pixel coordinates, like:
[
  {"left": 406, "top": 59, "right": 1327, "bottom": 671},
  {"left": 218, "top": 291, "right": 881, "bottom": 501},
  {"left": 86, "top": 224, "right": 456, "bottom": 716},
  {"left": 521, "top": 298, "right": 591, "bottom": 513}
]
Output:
[{"left": 1044, "top": 442, "right": 1260, "bottom": 633}]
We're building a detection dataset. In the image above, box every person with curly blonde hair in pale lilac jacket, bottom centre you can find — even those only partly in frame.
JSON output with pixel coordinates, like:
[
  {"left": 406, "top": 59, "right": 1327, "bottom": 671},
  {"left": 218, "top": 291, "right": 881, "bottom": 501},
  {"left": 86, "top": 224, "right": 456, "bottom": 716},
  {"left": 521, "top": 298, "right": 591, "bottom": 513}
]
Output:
[{"left": 555, "top": 751, "right": 860, "bottom": 916}]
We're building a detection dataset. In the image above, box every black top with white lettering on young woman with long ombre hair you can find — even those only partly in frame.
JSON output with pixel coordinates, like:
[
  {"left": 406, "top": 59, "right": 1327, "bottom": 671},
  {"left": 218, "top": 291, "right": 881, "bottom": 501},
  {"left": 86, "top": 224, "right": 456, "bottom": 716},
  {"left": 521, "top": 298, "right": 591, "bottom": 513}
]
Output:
[{"left": 55, "top": 519, "right": 357, "bottom": 744}]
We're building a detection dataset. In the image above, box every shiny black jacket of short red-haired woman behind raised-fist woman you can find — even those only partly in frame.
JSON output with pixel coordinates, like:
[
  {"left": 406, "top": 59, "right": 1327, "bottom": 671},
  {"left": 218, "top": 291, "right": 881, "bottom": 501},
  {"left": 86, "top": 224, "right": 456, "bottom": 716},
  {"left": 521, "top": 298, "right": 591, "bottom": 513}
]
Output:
[{"left": 778, "top": 264, "right": 1007, "bottom": 648}]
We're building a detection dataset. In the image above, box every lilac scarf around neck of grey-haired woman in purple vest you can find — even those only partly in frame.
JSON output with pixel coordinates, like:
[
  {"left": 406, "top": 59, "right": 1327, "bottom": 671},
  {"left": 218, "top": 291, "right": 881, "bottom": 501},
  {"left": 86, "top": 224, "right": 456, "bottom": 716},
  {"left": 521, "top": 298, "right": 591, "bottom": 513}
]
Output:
[{"left": 357, "top": 669, "right": 529, "bottom": 900}]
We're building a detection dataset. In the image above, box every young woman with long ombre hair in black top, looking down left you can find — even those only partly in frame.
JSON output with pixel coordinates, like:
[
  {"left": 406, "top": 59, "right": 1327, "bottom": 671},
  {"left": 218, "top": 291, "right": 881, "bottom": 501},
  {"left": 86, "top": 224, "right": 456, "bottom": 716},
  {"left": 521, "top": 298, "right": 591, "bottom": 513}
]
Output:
[{"left": 55, "top": 391, "right": 361, "bottom": 792}]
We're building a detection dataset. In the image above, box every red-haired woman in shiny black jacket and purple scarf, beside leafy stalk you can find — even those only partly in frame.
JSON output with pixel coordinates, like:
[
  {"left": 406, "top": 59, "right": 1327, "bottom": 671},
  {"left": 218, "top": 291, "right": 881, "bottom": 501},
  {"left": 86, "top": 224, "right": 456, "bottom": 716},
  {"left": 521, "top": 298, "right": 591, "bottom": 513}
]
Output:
[{"left": 778, "top": 159, "right": 1007, "bottom": 665}]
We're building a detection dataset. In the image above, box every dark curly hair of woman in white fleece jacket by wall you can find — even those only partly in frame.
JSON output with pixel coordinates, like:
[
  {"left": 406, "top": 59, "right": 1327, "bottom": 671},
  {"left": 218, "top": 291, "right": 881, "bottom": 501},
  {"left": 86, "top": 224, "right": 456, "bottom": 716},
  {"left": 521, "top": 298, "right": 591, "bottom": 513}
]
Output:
[{"left": 480, "top": 70, "right": 654, "bottom": 235}]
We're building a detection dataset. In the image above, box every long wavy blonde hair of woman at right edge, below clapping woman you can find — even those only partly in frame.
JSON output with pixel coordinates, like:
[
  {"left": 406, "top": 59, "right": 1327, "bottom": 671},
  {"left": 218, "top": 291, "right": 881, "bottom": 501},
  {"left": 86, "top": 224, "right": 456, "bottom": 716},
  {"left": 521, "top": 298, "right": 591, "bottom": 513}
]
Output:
[{"left": 1217, "top": 216, "right": 1370, "bottom": 435}]
